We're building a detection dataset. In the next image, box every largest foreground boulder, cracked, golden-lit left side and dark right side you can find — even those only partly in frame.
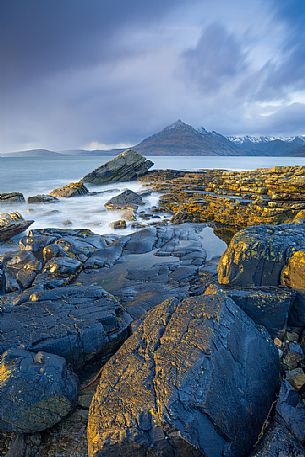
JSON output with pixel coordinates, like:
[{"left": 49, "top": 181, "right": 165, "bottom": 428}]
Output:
[{"left": 88, "top": 294, "right": 279, "bottom": 457}]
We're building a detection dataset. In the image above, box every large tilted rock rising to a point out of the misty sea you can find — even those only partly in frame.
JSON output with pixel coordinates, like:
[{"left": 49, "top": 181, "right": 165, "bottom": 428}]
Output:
[{"left": 82, "top": 149, "right": 153, "bottom": 185}]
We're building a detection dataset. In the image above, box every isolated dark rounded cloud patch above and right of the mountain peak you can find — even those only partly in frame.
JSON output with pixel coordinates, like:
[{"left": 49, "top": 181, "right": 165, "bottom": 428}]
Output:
[{"left": 183, "top": 23, "right": 247, "bottom": 91}]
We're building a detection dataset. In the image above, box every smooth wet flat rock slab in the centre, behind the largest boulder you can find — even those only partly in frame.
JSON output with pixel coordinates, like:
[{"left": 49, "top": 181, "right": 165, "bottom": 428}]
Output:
[{"left": 76, "top": 224, "right": 207, "bottom": 319}]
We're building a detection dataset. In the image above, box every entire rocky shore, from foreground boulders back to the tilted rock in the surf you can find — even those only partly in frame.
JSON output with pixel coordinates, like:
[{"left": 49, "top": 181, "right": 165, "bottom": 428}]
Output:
[{"left": 0, "top": 150, "right": 305, "bottom": 457}]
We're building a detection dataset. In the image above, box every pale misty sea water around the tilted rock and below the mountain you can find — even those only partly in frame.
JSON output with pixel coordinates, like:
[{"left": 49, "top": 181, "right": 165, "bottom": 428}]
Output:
[{"left": 0, "top": 156, "right": 305, "bottom": 242}]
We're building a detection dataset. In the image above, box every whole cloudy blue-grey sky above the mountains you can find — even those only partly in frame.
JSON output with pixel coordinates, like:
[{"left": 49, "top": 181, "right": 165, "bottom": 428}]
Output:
[{"left": 0, "top": 0, "right": 305, "bottom": 152}]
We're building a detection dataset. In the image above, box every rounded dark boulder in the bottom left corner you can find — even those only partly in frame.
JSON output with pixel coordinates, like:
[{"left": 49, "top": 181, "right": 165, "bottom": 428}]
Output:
[{"left": 0, "top": 348, "right": 78, "bottom": 433}]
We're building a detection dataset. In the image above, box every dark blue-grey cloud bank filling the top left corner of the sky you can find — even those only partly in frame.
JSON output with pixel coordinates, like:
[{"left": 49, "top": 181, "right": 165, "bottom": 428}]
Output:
[{"left": 0, "top": 0, "right": 180, "bottom": 85}]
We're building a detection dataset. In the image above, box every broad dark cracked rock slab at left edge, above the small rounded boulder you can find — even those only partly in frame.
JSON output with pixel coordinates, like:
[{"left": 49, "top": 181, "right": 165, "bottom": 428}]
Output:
[{"left": 0, "top": 286, "right": 131, "bottom": 368}]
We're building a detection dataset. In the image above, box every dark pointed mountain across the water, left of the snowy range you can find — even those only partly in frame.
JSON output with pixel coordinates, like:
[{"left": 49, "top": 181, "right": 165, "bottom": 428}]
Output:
[{"left": 133, "top": 120, "right": 238, "bottom": 156}]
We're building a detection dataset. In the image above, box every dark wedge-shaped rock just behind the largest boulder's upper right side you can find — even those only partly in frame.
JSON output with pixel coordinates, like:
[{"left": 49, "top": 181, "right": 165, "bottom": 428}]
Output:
[{"left": 225, "top": 287, "right": 295, "bottom": 338}]
